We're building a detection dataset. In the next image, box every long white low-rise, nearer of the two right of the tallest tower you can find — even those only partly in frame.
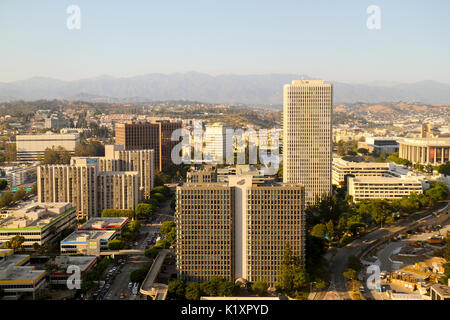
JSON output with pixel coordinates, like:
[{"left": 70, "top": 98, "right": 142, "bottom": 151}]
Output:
[{"left": 348, "top": 176, "right": 423, "bottom": 202}]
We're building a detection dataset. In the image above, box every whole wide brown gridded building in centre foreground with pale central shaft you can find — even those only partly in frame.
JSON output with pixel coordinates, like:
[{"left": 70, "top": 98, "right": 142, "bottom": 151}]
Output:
[{"left": 176, "top": 176, "right": 305, "bottom": 286}]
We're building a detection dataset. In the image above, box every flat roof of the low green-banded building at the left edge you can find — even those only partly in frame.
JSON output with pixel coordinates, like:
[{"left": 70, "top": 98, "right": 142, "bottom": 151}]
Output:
[{"left": 0, "top": 201, "right": 75, "bottom": 230}]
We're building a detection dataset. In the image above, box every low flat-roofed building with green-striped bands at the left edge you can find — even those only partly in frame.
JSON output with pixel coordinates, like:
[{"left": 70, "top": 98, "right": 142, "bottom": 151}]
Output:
[{"left": 0, "top": 202, "right": 76, "bottom": 250}]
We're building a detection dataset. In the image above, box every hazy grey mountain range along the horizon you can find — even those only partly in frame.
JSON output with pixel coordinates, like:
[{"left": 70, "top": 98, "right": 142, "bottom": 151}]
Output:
[{"left": 0, "top": 72, "right": 450, "bottom": 105}]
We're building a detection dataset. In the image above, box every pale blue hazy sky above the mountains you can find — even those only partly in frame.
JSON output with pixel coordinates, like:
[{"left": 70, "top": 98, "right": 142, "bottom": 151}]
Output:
[{"left": 0, "top": 0, "right": 450, "bottom": 83}]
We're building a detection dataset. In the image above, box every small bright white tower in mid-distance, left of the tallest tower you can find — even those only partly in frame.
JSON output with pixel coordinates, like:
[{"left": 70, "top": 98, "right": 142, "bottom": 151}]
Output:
[{"left": 204, "top": 122, "right": 226, "bottom": 164}]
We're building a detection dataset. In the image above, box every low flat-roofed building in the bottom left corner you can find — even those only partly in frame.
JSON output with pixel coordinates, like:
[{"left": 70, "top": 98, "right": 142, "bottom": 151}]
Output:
[{"left": 0, "top": 249, "right": 47, "bottom": 300}]
